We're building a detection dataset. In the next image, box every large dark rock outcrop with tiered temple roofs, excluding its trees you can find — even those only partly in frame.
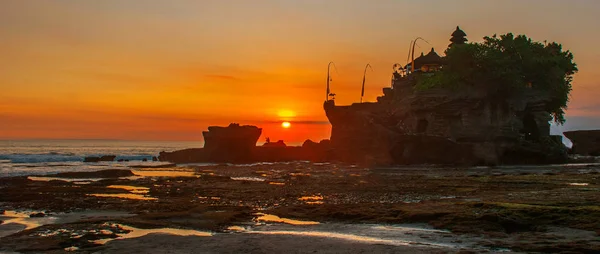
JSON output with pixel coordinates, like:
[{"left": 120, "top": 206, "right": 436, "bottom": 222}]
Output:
[{"left": 324, "top": 27, "right": 567, "bottom": 165}]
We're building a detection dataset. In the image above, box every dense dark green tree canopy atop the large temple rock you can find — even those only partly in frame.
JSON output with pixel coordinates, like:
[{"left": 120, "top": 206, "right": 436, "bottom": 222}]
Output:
[{"left": 417, "top": 33, "right": 577, "bottom": 124}]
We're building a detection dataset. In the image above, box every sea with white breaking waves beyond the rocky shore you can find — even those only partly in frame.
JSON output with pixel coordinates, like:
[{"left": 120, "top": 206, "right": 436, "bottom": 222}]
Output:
[{"left": 0, "top": 140, "right": 203, "bottom": 177}]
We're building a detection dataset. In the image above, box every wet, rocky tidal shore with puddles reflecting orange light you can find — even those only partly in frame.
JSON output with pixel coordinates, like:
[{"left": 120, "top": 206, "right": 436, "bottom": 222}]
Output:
[{"left": 0, "top": 162, "right": 600, "bottom": 253}]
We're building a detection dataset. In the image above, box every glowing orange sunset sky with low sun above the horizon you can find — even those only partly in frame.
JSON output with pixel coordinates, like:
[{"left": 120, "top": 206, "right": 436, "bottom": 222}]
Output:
[{"left": 0, "top": 0, "right": 600, "bottom": 142}]
